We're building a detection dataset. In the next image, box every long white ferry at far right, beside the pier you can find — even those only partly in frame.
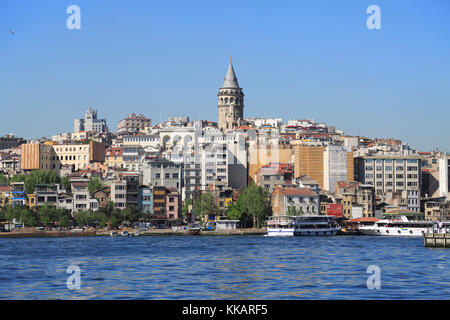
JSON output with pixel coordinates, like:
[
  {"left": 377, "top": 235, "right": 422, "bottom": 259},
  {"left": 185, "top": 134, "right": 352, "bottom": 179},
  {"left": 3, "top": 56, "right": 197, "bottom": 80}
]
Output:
[{"left": 359, "top": 216, "right": 433, "bottom": 237}]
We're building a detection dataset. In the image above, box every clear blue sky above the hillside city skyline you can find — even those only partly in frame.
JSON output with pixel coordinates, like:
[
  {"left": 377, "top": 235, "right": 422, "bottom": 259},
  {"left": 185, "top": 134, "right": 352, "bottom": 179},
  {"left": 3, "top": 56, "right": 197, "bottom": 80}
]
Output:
[{"left": 0, "top": 0, "right": 450, "bottom": 151}]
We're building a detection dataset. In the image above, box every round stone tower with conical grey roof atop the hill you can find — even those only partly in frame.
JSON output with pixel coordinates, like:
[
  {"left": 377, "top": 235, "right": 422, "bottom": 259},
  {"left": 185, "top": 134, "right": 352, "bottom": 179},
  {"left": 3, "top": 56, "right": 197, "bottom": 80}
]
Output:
[{"left": 217, "top": 58, "right": 244, "bottom": 130}]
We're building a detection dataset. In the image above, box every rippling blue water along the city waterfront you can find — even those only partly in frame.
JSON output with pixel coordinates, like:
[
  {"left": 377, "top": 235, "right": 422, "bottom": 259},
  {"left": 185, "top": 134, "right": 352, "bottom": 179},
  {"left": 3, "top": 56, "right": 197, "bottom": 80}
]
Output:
[{"left": 0, "top": 236, "right": 450, "bottom": 299}]
